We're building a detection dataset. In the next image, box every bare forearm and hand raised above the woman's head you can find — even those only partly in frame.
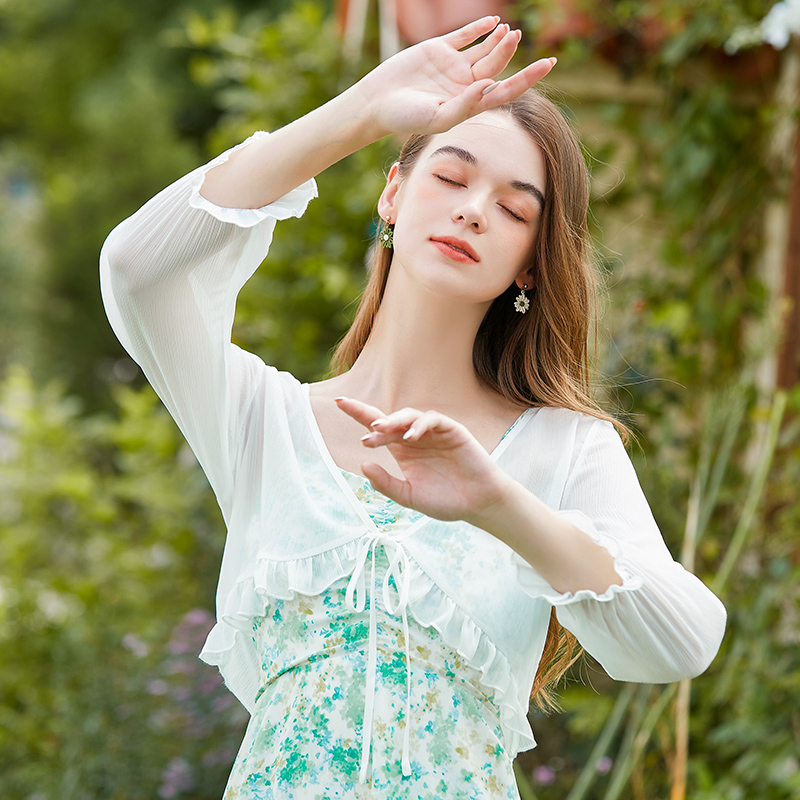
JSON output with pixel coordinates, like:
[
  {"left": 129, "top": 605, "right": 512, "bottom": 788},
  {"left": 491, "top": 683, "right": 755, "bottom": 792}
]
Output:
[{"left": 202, "top": 17, "right": 555, "bottom": 208}]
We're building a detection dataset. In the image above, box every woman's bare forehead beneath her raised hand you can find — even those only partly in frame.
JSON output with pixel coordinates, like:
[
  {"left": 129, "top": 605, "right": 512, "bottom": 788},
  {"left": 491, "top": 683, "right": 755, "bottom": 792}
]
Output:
[{"left": 420, "top": 111, "right": 545, "bottom": 190}]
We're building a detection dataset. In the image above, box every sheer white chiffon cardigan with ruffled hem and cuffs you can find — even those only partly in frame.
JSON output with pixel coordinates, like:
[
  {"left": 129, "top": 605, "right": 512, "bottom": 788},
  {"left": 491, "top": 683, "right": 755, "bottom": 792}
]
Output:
[{"left": 100, "top": 133, "right": 725, "bottom": 757}]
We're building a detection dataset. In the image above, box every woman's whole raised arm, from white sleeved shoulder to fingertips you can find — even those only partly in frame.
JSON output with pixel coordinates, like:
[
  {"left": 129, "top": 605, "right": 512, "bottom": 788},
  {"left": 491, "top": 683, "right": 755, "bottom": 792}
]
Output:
[{"left": 100, "top": 17, "right": 552, "bottom": 514}]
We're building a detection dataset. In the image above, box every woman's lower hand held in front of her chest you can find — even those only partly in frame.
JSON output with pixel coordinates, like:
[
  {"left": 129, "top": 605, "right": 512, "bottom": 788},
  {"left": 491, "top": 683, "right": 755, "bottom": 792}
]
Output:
[{"left": 336, "top": 397, "right": 511, "bottom": 522}]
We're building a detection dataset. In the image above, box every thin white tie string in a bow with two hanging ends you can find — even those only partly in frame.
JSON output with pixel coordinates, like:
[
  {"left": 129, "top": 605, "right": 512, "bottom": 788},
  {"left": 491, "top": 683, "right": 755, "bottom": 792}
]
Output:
[{"left": 346, "top": 532, "right": 411, "bottom": 783}]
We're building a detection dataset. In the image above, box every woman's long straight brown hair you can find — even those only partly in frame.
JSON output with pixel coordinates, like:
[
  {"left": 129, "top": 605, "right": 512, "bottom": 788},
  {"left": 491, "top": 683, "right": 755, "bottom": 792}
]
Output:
[{"left": 331, "top": 89, "right": 627, "bottom": 709}]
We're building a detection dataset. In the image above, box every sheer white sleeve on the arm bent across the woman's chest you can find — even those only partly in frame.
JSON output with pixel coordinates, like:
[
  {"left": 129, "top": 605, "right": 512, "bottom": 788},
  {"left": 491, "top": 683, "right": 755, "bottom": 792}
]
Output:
[{"left": 513, "top": 420, "right": 726, "bottom": 683}]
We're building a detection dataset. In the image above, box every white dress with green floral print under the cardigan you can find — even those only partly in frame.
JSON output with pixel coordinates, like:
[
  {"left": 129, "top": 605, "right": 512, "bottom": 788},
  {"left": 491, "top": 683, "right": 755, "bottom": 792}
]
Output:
[{"left": 224, "top": 470, "right": 519, "bottom": 800}]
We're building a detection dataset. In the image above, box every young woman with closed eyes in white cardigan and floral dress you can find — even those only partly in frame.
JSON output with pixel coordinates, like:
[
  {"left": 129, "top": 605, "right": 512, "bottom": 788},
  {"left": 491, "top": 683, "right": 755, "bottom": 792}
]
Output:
[{"left": 101, "top": 17, "right": 725, "bottom": 800}]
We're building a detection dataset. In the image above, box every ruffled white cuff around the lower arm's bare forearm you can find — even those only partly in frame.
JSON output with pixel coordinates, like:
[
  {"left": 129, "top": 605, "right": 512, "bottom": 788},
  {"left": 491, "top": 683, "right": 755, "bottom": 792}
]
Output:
[{"left": 511, "top": 511, "right": 642, "bottom": 606}]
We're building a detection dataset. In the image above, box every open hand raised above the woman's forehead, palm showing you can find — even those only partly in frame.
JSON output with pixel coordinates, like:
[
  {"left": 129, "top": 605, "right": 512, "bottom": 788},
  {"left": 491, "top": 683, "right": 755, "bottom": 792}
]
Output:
[{"left": 351, "top": 17, "right": 555, "bottom": 138}]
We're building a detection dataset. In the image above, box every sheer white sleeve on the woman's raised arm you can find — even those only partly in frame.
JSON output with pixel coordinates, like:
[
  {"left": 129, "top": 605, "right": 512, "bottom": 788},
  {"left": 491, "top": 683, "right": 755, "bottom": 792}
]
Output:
[{"left": 100, "top": 133, "right": 316, "bottom": 522}]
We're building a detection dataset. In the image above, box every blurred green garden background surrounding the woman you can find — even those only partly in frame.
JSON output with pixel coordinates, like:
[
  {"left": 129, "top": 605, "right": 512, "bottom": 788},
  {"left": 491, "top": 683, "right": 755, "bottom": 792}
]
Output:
[{"left": 0, "top": 0, "right": 800, "bottom": 800}]
